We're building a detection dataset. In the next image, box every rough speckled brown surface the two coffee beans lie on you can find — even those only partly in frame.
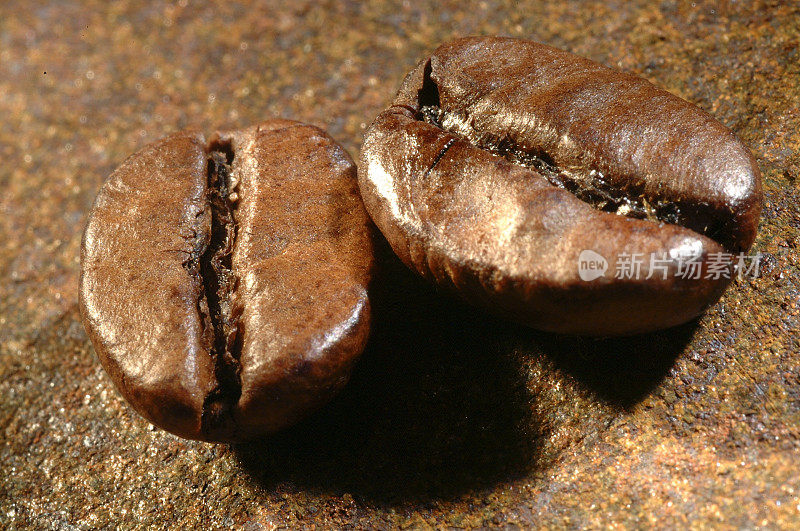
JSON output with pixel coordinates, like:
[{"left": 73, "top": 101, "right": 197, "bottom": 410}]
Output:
[{"left": 0, "top": 0, "right": 800, "bottom": 529}]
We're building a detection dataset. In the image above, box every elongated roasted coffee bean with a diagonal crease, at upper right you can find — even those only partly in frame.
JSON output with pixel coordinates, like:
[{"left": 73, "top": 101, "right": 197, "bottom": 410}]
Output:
[{"left": 359, "top": 37, "right": 761, "bottom": 335}]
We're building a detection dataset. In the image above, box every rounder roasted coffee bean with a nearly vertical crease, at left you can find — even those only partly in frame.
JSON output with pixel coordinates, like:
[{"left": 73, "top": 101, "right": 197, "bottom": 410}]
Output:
[{"left": 80, "top": 120, "right": 373, "bottom": 441}]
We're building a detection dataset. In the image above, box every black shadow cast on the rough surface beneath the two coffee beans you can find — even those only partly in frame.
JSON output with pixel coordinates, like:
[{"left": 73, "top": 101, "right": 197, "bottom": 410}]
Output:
[{"left": 234, "top": 240, "right": 695, "bottom": 503}]
